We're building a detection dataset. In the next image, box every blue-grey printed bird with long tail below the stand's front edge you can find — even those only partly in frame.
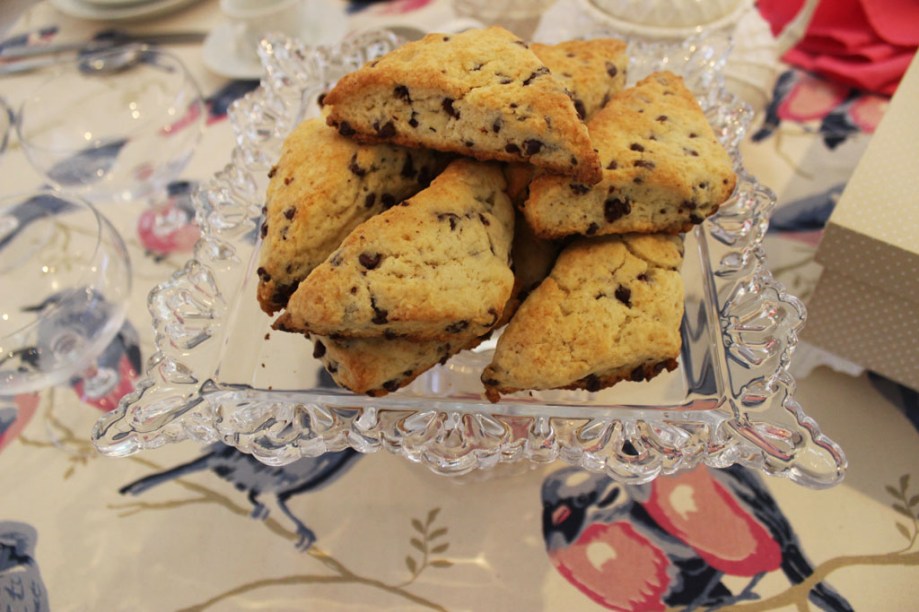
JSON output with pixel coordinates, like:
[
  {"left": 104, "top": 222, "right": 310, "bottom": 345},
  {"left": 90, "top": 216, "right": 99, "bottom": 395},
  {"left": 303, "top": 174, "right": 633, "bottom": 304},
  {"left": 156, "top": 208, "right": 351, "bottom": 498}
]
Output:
[{"left": 119, "top": 443, "right": 361, "bottom": 550}]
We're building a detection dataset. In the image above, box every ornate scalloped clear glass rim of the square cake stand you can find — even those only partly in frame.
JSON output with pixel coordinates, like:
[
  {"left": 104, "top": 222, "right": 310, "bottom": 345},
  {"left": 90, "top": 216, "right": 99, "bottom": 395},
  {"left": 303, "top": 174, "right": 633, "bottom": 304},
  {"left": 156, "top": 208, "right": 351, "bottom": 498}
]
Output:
[{"left": 92, "top": 31, "right": 846, "bottom": 488}]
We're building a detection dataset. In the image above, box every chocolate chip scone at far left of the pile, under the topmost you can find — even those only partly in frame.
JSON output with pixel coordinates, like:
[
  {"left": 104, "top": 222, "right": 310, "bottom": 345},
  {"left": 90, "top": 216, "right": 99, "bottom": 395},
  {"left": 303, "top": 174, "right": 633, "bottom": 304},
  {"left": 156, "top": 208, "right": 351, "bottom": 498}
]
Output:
[{"left": 258, "top": 118, "right": 448, "bottom": 314}]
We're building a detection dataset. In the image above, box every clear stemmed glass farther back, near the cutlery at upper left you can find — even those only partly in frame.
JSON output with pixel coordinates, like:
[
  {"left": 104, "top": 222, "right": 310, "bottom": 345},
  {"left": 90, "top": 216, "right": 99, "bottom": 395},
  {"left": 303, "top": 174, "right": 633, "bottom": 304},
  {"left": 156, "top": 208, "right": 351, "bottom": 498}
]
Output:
[{"left": 16, "top": 45, "right": 206, "bottom": 230}]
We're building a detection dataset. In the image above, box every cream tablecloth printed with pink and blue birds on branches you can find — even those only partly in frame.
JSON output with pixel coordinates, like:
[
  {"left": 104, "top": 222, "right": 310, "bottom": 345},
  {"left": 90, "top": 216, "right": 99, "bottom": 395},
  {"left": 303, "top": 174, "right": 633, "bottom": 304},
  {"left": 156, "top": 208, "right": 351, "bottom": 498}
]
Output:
[{"left": 0, "top": 0, "right": 919, "bottom": 611}]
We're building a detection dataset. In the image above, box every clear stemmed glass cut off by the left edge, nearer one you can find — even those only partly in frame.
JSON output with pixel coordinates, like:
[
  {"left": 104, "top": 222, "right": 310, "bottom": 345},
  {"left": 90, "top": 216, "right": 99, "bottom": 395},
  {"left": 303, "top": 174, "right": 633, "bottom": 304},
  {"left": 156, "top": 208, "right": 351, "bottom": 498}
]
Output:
[{"left": 0, "top": 190, "right": 131, "bottom": 397}]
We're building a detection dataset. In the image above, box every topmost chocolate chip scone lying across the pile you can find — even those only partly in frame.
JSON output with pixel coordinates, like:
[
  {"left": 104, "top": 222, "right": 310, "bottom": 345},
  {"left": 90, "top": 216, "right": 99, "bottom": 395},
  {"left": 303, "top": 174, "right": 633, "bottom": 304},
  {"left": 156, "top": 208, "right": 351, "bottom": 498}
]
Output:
[{"left": 324, "top": 27, "right": 600, "bottom": 184}]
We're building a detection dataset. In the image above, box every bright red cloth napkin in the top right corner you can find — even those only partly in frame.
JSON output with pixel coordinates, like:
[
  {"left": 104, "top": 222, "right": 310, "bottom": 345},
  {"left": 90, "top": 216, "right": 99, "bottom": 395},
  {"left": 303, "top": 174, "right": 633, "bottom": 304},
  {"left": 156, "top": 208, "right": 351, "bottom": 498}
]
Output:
[{"left": 757, "top": 0, "right": 919, "bottom": 95}]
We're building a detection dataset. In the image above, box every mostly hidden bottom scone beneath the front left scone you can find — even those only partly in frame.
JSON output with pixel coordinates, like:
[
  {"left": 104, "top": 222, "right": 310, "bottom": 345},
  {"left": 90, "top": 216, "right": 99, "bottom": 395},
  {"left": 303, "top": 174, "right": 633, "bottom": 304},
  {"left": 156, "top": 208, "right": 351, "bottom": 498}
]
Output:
[{"left": 312, "top": 333, "right": 481, "bottom": 397}]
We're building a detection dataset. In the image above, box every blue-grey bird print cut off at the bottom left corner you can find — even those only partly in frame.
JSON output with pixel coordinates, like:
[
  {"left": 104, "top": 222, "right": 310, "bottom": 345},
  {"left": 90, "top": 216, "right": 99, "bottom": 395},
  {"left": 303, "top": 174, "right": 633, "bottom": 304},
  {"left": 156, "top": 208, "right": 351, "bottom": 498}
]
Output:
[{"left": 0, "top": 521, "right": 50, "bottom": 612}]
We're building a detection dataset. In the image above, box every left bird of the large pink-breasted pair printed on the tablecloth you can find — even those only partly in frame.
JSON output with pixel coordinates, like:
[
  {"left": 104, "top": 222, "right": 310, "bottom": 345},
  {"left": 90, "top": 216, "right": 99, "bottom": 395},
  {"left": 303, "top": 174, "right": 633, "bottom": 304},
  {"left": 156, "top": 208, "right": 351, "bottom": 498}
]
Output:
[{"left": 542, "top": 467, "right": 734, "bottom": 610}]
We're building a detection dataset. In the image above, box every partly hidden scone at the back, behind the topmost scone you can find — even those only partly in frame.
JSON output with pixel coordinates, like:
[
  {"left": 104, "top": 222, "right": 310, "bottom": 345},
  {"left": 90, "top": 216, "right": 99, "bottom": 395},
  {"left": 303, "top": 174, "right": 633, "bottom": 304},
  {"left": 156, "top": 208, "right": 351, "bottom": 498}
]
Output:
[{"left": 530, "top": 38, "right": 629, "bottom": 119}]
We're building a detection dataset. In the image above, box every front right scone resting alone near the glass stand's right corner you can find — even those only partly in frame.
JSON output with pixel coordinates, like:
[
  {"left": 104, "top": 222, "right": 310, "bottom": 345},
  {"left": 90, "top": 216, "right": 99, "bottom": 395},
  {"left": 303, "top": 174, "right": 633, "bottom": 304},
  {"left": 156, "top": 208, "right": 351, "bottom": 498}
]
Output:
[{"left": 482, "top": 234, "right": 683, "bottom": 401}]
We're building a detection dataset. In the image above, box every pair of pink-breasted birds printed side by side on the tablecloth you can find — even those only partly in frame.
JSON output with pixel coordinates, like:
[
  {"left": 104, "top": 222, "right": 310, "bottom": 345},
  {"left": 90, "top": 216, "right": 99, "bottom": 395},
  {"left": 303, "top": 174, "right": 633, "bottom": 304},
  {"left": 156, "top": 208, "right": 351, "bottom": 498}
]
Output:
[{"left": 542, "top": 466, "right": 851, "bottom": 610}]
